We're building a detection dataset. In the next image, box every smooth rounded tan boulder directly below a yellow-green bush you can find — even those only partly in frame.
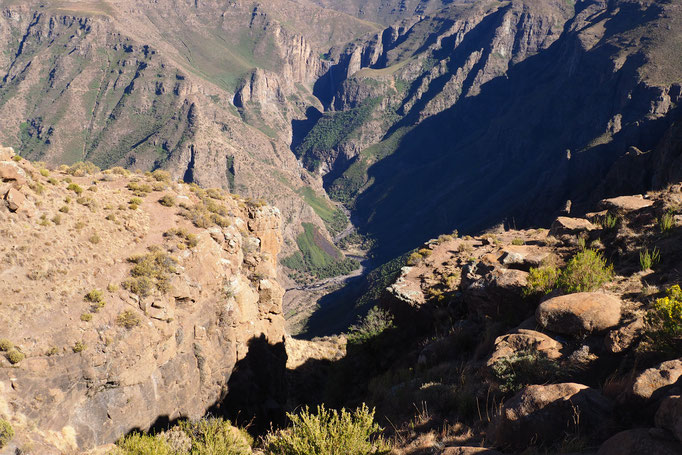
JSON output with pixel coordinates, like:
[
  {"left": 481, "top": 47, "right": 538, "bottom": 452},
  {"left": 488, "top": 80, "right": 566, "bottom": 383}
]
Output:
[{"left": 535, "top": 292, "right": 621, "bottom": 335}]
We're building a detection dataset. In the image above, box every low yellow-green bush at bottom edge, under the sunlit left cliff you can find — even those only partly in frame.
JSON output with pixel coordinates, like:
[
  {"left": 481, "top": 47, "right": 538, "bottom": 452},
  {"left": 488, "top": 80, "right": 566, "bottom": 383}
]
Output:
[{"left": 114, "top": 418, "right": 252, "bottom": 455}]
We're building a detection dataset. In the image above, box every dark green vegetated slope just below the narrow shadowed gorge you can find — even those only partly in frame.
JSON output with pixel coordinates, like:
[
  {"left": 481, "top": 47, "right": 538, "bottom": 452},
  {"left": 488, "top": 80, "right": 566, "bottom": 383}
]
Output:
[{"left": 295, "top": 98, "right": 381, "bottom": 171}]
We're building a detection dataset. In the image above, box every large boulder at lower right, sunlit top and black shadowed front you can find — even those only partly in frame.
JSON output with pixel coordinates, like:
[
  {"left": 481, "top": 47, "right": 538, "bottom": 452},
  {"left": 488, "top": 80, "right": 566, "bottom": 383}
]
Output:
[{"left": 489, "top": 383, "right": 612, "bottom": 449}]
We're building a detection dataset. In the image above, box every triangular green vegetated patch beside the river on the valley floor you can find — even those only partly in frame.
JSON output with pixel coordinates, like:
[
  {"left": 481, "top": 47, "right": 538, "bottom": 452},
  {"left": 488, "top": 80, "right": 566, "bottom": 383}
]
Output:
[{"left": 282, "top": 223, "right": 360, "bottom": 279}]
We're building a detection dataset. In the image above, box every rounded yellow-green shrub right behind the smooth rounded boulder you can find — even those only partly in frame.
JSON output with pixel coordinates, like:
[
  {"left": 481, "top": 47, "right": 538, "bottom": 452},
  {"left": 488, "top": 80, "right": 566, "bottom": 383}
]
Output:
[{"left": 558, "top": 249, "right": 613, "bottom": 293}]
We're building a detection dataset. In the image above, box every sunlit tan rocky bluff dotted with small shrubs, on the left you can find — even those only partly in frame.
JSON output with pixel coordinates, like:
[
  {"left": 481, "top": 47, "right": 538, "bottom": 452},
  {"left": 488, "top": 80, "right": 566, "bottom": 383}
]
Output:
[{"left": 0, "top": 149, "right": 286, "bottom": 454}]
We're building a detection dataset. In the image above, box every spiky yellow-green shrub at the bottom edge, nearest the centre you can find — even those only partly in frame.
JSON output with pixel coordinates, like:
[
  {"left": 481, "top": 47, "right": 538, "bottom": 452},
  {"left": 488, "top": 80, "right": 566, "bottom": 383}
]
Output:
[{"left": 265, "top": 404, "right": 389, "bottom": 455}]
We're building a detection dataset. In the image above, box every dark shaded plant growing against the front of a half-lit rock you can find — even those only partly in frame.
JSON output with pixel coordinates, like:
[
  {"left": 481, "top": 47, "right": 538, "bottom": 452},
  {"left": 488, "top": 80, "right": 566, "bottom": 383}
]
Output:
[{"left": 491, "top": 350, "right": 561, "bottom": 393}]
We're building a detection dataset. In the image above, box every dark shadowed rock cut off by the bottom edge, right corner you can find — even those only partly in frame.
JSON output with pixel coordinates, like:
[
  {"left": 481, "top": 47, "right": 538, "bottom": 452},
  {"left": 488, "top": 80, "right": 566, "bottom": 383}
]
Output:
[{"left": 597, "top": 428, "right": 682, "bottom": 455}]
